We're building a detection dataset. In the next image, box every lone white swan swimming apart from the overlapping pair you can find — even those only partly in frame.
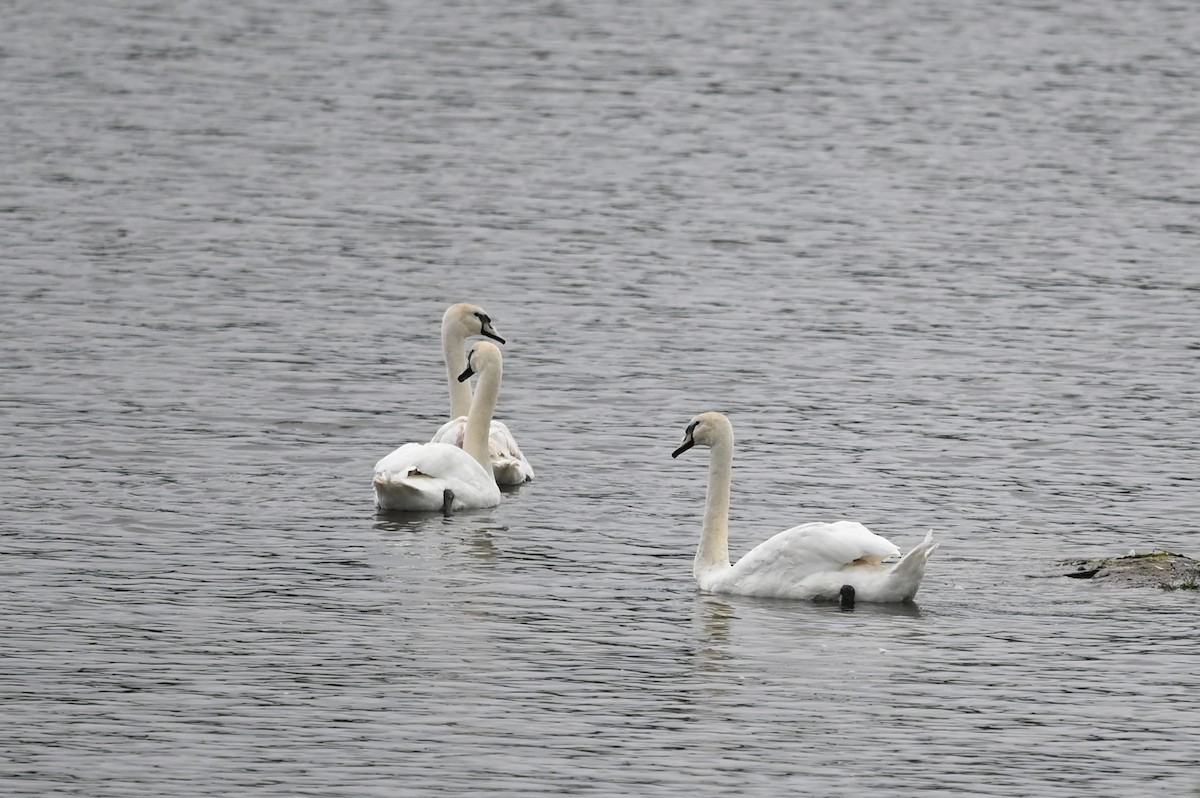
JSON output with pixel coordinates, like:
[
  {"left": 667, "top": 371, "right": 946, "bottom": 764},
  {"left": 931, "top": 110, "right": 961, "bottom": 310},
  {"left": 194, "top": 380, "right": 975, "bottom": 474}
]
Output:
[{"left": 671, "top": 413, "right": 937, "bottom": 606}]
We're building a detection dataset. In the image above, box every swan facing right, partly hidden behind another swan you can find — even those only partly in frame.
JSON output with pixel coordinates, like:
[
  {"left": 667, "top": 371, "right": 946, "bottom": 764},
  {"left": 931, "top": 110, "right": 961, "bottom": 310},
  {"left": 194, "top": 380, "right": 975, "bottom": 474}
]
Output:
[{"left": 430, "top": 302, "right": 533, "bottom": 485}]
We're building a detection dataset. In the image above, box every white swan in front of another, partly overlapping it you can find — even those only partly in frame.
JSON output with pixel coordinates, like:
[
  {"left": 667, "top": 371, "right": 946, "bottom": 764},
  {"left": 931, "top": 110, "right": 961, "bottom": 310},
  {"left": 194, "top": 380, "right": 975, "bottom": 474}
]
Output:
[{"left": 372, "top": 341, "right": 504, "bottom": 515}]
